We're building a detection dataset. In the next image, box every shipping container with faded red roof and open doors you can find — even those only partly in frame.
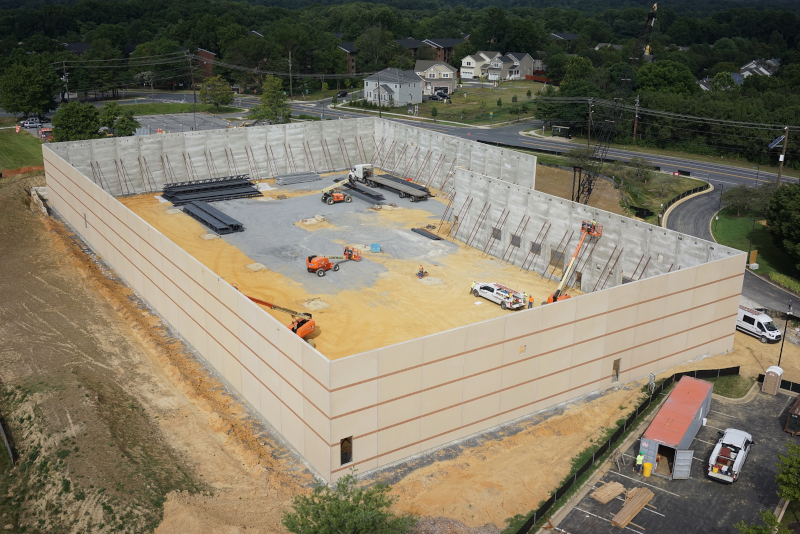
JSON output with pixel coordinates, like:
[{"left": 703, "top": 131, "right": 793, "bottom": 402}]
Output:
[{"left": 639, "top": 376, "right": 714, "bottom": 479}]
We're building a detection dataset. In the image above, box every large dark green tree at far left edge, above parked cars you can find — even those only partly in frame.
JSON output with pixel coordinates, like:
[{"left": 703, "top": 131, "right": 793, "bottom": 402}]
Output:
[{"left": 0, "top": 64, "right": 61, "bottom": 116}]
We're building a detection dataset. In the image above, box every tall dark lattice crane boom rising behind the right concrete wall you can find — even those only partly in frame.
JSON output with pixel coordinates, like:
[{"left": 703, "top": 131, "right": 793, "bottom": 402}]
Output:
[{"left": 572, "top": 4, "right": 658, "bottom": 204}]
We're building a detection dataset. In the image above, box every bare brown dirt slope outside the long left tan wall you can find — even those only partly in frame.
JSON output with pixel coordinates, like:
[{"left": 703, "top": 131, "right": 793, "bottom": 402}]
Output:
[{"left": 0, "top": 177, "right": 312, "bottom": 532}]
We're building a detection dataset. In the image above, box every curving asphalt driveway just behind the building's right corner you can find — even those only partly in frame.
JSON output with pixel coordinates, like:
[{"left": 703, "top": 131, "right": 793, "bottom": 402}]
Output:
[{"left": 667, "top": 181, "right": 797, "bottom": 311}]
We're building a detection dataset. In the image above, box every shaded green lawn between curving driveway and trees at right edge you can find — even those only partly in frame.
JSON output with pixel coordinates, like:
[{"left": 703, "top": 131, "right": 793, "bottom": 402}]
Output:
[{"left": 711, "top": 208, "right": 798, "bottom": 286}]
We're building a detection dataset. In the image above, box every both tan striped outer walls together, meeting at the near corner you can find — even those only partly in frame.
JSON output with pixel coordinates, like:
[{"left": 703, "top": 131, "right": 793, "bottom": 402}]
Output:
[{"left": 43, "top": 126, "right": 743, "bottom": 486}]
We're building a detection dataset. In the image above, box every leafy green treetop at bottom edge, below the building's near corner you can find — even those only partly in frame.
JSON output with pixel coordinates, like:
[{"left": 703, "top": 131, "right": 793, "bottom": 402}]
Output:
[{"left": 281, "top": 472, "right": 417, "bottom": 534}]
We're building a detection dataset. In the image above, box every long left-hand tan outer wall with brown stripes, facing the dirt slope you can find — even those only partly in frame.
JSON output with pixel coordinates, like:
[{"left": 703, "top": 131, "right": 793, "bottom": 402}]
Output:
[{"left": 42, "top": 146, "right": 330, "bottom": 477}]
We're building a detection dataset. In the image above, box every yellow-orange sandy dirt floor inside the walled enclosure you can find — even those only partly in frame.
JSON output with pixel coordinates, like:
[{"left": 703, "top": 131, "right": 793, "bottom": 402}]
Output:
[{"left": 120, "top": 189, "right": 578, "bottom": 359}]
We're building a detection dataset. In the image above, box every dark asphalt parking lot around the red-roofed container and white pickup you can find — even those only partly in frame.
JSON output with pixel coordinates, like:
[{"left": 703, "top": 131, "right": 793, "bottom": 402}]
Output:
[{"left": 558, "top": 393, "right": 800, "bottom": 534}]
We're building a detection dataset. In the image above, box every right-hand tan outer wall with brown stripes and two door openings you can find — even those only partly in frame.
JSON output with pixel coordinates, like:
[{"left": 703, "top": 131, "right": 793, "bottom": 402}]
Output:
[{"left": 330, "top": 255, "right": 744, "bottom": 479}]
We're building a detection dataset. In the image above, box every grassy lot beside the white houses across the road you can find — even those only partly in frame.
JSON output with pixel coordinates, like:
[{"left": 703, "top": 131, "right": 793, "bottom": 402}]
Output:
[{"left": 410, "top": 82, "right": 542, "bottom": 125}]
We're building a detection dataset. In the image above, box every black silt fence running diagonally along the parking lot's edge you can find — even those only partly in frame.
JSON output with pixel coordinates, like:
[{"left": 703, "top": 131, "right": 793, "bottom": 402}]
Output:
[{"left": 517, "top": 366, "right": 740, "bottom": 534}]
